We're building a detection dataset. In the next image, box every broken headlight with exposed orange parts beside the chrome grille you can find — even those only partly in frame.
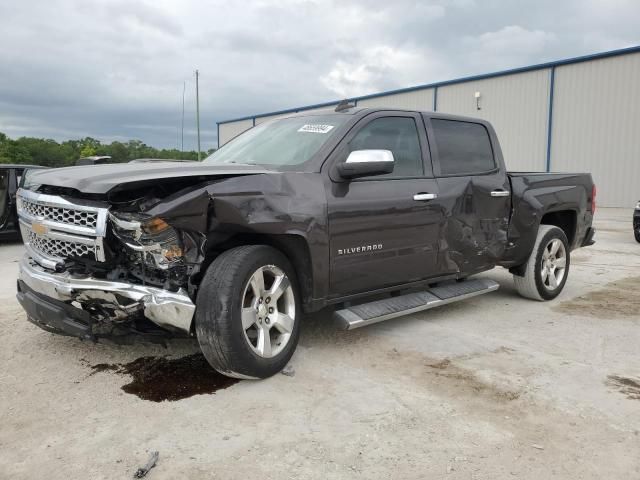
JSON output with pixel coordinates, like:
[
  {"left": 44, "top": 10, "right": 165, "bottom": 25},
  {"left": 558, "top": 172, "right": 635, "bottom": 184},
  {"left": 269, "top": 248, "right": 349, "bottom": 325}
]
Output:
[{"left": 110, "top": 213, "right": 183, "bottom": 270}]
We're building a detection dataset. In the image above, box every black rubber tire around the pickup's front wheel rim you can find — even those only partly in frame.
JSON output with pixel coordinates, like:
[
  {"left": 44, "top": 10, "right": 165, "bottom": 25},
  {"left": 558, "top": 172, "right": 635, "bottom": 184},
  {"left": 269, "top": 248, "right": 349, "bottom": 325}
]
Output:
[{"left": 195, "top": 245, "right": 302, "bottom": 379}]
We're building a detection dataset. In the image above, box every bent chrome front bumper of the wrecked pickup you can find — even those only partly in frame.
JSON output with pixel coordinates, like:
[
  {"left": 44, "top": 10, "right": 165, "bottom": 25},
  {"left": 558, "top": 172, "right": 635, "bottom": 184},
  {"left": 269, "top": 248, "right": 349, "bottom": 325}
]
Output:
[{"left": 18, "top": 255, "right": 196, "bottom": 336}]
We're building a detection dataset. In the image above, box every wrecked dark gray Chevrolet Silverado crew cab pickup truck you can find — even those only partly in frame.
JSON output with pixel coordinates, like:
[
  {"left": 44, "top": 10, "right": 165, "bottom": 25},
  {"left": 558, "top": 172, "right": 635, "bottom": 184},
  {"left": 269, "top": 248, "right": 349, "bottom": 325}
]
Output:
[{"left": 13, "top": 106, "right": 595, "bottom": 378}]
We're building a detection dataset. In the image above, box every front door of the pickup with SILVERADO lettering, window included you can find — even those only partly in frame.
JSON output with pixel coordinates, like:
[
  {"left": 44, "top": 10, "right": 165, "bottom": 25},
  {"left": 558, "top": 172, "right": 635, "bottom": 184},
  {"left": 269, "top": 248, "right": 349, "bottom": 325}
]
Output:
[{"left": 325, "top": 112, "right": 442, "bottom": 298}]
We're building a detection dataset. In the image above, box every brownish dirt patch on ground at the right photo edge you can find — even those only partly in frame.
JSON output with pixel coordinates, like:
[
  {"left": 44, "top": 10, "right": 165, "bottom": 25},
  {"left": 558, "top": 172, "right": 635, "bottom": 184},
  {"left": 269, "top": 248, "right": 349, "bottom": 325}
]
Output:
[{"left": 553, "top": 277, "right": 640, "bottom": 318}]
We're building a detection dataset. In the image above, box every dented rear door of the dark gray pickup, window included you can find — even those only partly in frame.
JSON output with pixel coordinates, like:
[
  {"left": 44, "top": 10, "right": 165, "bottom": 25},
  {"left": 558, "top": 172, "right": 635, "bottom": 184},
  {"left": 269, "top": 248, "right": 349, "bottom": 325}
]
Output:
[{"left": 425, "top": 116, "right": 511, "bottom": 275}]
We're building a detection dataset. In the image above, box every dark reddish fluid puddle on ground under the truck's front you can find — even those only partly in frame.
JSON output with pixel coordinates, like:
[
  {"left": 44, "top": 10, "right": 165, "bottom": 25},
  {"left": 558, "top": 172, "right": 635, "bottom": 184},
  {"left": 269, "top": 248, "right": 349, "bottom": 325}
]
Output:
[{"left": 91, "top": 354, "right": 239, "bottom": 402}]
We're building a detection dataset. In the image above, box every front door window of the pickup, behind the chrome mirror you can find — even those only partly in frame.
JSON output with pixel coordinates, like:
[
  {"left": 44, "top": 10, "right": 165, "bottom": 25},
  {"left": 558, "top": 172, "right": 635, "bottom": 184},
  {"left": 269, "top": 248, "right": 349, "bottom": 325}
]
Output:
[{"left": 349, "top": 117, "right": 424, "bottom": 177}]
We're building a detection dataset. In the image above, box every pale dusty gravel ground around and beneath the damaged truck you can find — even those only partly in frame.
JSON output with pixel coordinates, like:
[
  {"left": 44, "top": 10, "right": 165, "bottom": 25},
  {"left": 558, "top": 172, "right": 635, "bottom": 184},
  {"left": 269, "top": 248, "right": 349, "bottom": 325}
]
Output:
[{"left": 0, "top": 209, "right": 640, "bottom": 480}]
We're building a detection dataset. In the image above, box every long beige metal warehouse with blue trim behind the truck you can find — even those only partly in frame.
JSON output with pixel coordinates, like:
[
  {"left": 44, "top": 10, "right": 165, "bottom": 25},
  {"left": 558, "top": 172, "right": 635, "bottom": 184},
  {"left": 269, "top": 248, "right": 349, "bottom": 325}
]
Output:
[{"left": 218, "top": 46, "right": 640, "bottom": 207}]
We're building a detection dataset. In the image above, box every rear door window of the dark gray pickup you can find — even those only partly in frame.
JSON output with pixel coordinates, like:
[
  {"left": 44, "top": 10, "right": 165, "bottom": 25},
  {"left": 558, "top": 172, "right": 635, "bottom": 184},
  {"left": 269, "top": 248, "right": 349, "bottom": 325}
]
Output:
[{"left": 431, "top": 118, "right": 496, "bottom": 175}]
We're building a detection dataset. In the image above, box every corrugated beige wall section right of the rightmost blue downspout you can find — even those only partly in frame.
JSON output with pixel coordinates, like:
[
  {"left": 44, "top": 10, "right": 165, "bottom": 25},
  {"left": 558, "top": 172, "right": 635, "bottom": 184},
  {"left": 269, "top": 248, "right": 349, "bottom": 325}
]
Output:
[{"left": 551, "top": 53, "right": 640, "bottom": 207}]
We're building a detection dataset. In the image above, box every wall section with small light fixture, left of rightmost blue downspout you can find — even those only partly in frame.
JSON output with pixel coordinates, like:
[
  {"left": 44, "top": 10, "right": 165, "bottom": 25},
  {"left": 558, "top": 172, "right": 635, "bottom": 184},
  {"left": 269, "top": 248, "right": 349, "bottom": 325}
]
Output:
[{"left": 437, "top": 69, "right": 549, "bottom": 171}]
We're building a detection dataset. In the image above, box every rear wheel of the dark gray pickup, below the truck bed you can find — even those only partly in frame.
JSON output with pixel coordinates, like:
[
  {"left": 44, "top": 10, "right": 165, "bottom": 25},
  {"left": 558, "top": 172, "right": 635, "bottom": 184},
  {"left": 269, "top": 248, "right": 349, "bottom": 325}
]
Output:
[{"left": 513, "top": 225, "right": 571, "bottom": 301}]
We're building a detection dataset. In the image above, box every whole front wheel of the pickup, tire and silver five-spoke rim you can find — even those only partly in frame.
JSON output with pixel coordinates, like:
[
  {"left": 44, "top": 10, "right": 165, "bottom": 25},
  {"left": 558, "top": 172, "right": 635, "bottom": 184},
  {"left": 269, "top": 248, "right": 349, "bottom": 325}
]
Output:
[{"left": 196, "top": 245, "right": 301, "bottom": 378}]
